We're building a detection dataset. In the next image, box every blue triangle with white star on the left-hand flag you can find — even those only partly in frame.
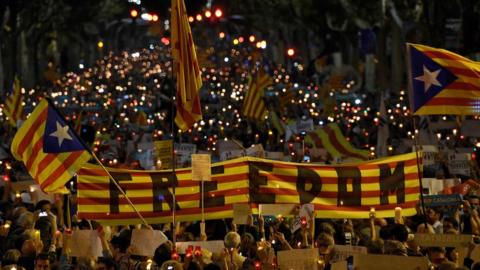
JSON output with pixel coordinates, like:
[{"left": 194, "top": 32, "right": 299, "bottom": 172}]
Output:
[{"left": 43, "top": 104, "right": 86, "bottom": 153}]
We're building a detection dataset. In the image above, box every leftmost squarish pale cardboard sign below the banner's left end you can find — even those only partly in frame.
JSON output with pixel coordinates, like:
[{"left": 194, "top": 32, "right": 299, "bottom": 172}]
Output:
[{"left": 68, "top": 230, "right": 102, "bottom": 257}]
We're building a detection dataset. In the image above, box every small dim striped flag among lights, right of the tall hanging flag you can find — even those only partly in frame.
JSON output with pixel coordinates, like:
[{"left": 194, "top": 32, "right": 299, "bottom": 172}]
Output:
[{"left": 242, "top": 69, "right": 273, "bottom": 121}]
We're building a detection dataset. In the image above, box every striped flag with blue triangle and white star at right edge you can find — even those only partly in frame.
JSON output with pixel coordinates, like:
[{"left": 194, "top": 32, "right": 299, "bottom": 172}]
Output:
[{"left": 407, "top": 44, "right": 480, "bottom": 115}]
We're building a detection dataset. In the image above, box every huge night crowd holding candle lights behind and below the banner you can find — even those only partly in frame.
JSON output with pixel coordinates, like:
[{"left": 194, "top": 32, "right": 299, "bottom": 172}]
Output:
[{"left": 0, "top": 19, "right": 480, "bottom": 270}]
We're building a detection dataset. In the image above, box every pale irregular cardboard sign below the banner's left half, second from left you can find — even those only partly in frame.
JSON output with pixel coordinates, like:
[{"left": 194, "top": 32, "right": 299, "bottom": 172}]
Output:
[{"left": 130, "top": 229, "right": 168, "bottom": 257}]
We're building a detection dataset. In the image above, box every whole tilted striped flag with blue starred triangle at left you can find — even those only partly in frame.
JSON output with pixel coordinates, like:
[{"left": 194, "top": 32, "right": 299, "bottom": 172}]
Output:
[{"left": 11, "top": 99, "right": 90, "bottom": 192}]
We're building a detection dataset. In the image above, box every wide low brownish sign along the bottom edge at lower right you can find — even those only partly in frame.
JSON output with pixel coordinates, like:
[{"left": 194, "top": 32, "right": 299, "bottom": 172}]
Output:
[{"left": 353, "top": 254, "right": 429, "bottom": 270}]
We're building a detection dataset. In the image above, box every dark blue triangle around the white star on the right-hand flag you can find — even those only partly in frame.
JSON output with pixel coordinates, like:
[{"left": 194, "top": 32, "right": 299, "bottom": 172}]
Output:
[{"left": 410, "top": 46, "right": 458, "bottom": 112}]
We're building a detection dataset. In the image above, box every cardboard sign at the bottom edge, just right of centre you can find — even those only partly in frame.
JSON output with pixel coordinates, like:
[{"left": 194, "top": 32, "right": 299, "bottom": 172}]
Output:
[{"left": 277, "top": 248, "right": 318, "bottom": 270}]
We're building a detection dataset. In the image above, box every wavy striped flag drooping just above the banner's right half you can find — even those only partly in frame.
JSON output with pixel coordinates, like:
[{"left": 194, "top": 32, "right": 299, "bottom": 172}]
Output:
[{"left": 305, "top": 123, "right": 369, "bottom": 160}]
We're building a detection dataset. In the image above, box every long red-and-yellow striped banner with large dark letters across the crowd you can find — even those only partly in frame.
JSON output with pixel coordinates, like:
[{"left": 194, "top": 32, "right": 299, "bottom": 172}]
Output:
[{"left": 77, "top": 153, "right": 420, "bottom": 224}]
